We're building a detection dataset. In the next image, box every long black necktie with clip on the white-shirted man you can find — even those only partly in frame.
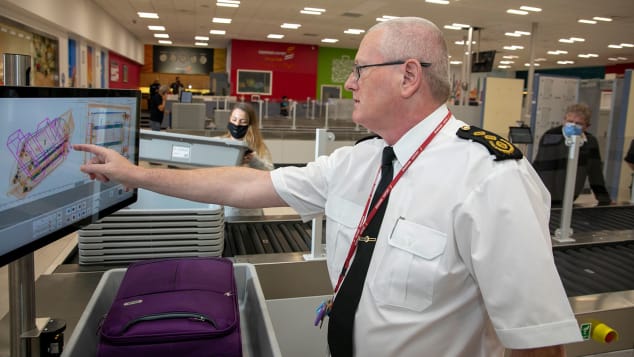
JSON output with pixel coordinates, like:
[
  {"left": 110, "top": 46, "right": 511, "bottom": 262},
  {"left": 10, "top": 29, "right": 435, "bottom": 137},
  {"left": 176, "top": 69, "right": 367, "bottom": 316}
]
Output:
[{"left": 328, "top": 146, "right": 395, "bottom": 357}]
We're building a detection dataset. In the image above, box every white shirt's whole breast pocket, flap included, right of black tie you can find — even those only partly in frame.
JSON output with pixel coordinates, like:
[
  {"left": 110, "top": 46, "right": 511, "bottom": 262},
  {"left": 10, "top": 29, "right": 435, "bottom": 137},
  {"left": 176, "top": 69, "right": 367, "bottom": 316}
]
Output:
[{"left": 370, "top": 218, "right": 447, "bottom": 311}]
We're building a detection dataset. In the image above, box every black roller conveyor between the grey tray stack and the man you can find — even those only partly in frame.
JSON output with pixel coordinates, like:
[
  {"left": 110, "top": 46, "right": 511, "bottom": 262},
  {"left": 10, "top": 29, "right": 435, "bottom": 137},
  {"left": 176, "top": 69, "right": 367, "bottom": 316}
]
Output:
[{"left": 223, "top": 221, "right": 312, "bottom": 257}]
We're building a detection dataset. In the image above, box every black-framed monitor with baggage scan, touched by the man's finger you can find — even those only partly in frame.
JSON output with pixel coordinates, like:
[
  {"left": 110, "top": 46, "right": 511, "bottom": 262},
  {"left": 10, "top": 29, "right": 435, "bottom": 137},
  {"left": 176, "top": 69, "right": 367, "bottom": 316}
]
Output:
[{"left": 0, "top": 86, "right": 141, "bottom": 266}]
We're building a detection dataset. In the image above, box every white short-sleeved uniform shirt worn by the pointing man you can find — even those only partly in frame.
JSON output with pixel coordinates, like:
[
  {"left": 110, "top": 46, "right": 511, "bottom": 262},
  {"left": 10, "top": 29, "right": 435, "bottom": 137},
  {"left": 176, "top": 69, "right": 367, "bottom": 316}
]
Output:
[{"left": 272, "top": 106, "right": 581, "bottom": 357}]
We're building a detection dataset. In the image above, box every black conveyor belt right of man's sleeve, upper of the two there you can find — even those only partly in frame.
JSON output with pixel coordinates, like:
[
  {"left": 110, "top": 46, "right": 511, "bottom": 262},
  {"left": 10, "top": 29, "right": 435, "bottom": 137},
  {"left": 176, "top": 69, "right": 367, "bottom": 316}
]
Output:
[{"left": 550, "top": 206, "right": 634, "bottom": 234}]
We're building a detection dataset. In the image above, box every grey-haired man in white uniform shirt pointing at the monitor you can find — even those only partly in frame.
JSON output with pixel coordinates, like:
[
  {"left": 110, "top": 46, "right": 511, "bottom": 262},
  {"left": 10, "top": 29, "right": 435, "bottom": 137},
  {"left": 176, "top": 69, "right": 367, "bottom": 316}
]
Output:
[{"left": 75, "top": 18, "right": 581, "bottom": 357}]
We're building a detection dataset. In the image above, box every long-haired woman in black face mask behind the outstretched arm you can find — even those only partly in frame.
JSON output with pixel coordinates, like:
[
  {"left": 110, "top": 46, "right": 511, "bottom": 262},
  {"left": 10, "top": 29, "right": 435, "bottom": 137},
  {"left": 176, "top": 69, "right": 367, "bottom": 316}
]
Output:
[{"left": 222, "top": 102, "right": 274, "bottom": 216}]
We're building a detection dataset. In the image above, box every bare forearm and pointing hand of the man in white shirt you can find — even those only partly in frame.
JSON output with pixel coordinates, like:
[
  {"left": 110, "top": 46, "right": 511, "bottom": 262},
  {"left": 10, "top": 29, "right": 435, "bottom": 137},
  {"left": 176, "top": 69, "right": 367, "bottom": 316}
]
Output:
[{"left": 73, "top": 144, "right": 286, "bottom": 208}]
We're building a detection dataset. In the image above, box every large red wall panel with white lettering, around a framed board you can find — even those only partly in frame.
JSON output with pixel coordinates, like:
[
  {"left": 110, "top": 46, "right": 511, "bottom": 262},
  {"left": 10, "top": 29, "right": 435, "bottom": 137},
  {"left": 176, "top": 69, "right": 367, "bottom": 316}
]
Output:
[{"left": 230, "top": 40, "right": 319, "bottom": 101}]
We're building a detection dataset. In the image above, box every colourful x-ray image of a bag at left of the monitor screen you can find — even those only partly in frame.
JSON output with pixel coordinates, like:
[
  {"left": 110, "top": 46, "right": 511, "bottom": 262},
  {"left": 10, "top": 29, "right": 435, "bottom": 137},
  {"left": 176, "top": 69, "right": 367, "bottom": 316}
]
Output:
[{"left": 7, "top": 110, "right": 75, "bottom": 199}]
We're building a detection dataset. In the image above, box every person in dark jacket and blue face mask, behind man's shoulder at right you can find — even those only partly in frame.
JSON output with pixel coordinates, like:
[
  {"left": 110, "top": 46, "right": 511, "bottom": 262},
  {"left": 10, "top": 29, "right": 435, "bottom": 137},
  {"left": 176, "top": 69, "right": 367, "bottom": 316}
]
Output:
[{"left": 533, "top": 103, "right": 613, "bottom": 207}]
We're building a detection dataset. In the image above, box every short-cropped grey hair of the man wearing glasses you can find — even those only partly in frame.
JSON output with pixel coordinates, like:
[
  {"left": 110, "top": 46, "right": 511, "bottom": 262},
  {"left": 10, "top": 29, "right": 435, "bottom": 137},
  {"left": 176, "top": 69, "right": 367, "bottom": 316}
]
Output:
[{"left": 368, "top": 17, "right": 451, "bottom": 102}]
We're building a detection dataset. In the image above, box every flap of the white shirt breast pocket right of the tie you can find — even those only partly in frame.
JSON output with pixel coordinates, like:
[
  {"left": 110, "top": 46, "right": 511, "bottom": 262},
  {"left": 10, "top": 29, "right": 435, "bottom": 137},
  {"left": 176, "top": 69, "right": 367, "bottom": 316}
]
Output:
[{"left": 389, "top": 218, "right": 447, "bottom": 260}]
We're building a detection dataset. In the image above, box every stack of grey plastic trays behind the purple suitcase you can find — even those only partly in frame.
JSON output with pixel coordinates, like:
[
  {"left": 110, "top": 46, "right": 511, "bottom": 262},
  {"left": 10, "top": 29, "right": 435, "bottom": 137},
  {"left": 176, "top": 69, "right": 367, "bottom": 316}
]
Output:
[{"left": 78, "top": 189, "right": 224, "bottom": 265}]
